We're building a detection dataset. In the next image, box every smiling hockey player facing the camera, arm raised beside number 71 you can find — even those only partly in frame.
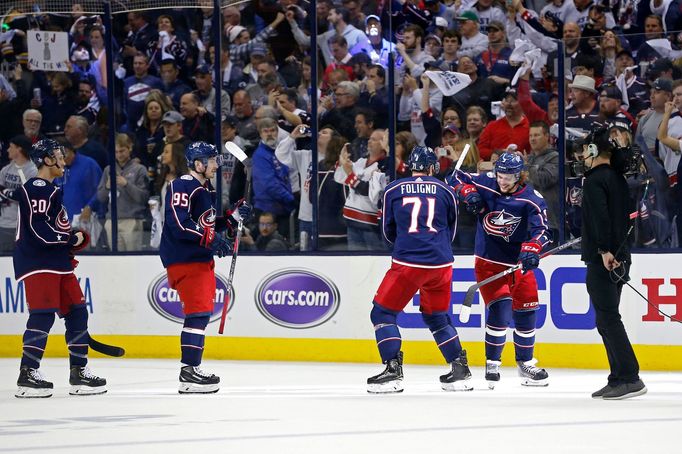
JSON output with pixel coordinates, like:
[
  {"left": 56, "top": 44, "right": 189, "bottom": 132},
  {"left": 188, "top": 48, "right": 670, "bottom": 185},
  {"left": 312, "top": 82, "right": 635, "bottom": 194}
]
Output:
[{"left": 452, "top": 151, "right": 551, "bottom": 389}]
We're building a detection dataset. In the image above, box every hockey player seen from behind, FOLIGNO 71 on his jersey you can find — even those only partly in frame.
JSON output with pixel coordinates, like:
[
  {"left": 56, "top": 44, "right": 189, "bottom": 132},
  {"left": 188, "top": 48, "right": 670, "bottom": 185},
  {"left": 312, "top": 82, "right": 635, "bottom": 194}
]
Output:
[{"left": 367, "top": 146, "right": 472, "bottom": 393}]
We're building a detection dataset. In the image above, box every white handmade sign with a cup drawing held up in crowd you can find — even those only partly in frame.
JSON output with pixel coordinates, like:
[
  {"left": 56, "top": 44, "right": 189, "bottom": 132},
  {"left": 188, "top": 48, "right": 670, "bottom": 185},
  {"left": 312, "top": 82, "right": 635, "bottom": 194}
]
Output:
[{"left": 27, "top": 30, "right": 69, "bottom": 72}]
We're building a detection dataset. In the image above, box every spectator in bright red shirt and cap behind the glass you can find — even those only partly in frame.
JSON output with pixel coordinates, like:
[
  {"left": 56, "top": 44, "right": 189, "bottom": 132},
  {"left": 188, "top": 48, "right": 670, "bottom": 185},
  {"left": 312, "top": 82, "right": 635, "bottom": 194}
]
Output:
[{"left": 478, "top": 89, "right": 530, "bottom": 161}]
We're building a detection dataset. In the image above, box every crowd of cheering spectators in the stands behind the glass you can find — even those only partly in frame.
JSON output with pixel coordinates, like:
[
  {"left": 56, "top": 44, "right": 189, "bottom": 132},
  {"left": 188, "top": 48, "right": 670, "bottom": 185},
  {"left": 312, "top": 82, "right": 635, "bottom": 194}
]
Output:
[{"left": 0, "top": 0, "right": 682, "bottom": 252}]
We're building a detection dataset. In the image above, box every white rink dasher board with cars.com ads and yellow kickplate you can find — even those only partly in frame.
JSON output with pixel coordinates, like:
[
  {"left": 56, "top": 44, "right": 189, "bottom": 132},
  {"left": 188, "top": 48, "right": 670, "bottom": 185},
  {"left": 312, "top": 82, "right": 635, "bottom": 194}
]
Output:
[{"left": 0, "top": 254, "right": 682, "bottom": 370}]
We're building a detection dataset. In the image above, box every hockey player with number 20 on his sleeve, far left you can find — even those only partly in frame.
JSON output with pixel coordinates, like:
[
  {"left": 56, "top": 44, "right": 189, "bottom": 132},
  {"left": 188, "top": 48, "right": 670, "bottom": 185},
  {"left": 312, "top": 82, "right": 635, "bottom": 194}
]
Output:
[{"left": 13, "top": 139, "right": 107, "bottom": 397}]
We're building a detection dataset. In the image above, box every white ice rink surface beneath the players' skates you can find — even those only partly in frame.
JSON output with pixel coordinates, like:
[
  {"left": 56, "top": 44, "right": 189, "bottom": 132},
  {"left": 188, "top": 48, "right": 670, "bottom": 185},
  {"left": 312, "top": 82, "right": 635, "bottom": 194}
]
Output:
[{"left": 0, "top": 358, "right": 682, "bottom": 454}]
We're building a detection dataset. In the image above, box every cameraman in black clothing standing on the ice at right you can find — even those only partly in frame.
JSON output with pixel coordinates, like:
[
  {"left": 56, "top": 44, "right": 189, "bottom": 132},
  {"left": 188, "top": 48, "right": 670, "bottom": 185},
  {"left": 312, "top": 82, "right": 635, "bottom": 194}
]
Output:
[{"left": 581, "top": 128, "right": 647, "bottom": 400}]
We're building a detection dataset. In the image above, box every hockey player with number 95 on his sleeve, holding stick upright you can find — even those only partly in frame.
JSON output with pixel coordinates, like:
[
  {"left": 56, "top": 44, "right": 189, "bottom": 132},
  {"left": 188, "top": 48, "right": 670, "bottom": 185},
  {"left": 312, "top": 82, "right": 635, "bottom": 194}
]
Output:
[{"left": 159, "top": 142, "right": 251, "bottom": 394}]
